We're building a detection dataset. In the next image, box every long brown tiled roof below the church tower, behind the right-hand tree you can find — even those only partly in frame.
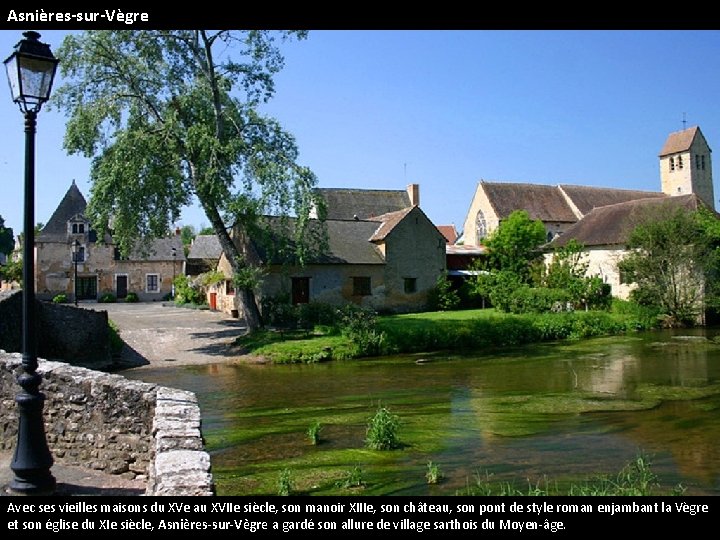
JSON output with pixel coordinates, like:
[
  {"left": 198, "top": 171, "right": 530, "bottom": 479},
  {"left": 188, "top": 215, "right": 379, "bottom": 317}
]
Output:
[{"left": 547, "top": 194, "right": 703, "bottom": 248}]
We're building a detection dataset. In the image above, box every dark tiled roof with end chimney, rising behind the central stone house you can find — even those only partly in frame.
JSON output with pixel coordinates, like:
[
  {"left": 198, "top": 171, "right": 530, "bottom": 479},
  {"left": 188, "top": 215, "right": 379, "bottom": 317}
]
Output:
[{"left": 318, "top": 188, "right": 411, "bottom": 219}]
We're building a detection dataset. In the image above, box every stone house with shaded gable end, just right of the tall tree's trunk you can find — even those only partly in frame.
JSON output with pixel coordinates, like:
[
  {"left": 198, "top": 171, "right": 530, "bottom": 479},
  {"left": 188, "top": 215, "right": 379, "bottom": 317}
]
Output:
[{"left": 209, "top": 202, "right": 445, "bottom": 312}]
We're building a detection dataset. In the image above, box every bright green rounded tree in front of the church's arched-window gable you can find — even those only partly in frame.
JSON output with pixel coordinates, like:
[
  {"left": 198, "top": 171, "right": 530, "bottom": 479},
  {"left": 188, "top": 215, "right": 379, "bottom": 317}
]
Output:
[{"left": 485, "top": 210, "right": 546, "bottom": 283}]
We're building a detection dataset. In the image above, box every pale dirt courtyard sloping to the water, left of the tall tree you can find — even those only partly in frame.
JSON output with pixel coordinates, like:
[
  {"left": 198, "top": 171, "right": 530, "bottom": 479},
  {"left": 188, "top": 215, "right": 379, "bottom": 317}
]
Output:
[{"left": 83, "top": 302, "right": 245, "bottom": 367}]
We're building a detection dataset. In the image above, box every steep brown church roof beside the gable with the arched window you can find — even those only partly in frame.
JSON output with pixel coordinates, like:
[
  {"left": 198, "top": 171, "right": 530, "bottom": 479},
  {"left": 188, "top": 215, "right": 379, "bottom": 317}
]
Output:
[{"left": 481, "top": 180, "right": 577, "bottom": 223}]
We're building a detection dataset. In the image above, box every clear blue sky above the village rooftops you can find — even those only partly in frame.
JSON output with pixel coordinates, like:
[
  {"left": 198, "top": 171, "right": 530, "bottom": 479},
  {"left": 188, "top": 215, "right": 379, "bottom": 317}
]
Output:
[{"left": 0, "top": 30, "right": 720, "bottom": 237}]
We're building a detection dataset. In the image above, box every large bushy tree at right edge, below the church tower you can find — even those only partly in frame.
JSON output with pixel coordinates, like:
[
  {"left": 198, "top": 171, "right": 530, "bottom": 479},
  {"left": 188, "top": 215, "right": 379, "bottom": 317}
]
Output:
[{"left": 618, "top": 206, "right": 720, "bottom": 326}]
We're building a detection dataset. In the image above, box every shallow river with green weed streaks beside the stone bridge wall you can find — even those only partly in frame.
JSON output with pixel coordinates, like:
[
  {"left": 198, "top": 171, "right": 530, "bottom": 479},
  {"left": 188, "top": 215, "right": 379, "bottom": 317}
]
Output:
[{"left": 123, "top": 330, "right": 720, "bottom": 495}]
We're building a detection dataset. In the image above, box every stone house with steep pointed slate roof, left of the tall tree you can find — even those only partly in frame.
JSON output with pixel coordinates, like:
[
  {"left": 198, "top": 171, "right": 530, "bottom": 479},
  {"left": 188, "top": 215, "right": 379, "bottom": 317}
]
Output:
[{"left": 35, "top": 181, "right": 185, "bottom": 301}]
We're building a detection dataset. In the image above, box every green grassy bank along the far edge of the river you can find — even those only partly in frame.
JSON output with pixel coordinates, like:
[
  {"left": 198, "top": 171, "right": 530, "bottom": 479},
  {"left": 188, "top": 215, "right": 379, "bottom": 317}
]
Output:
[{"left": 237, "top": 303, "right": 656, "bottom": 363}]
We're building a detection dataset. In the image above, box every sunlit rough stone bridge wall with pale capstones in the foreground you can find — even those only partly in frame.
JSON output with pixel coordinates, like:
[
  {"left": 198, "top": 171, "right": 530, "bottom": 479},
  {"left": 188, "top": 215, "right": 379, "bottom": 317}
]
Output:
[{"left": 0, "top": 351, "right": 213, "bottom": 495}]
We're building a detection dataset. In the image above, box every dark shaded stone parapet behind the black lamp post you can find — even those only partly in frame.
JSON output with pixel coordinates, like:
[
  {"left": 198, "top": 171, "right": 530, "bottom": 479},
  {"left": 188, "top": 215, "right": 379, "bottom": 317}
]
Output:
[{"left": 0, "top": 291, "right": 111, "bottom": 369}]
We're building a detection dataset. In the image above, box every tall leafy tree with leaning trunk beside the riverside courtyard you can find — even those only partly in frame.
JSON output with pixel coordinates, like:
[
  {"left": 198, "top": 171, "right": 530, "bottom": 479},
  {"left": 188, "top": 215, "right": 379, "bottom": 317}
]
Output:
[{"left": 54, "top": 30, "right": 322, "bottom": 331}]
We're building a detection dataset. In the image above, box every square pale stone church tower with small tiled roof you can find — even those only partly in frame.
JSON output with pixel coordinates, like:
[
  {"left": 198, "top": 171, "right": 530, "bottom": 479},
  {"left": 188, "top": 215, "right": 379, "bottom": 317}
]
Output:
[{"left": 660, "top": 126, "right": 715, "bottom": 210}]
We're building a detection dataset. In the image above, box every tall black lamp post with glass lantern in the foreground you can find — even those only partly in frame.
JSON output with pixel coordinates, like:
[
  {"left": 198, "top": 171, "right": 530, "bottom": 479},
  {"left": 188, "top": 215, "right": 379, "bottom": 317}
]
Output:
[{"left": 5, "top": 32, "right": 58, "bottom": 495}]
